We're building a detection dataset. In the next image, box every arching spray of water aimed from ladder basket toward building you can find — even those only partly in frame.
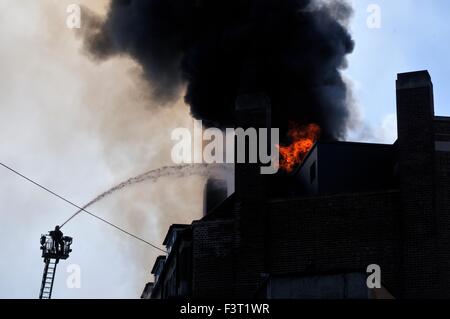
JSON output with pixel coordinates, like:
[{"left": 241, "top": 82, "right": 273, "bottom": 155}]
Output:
[{"left": 61, "top": 164, "right": 228, "bottom": 228}]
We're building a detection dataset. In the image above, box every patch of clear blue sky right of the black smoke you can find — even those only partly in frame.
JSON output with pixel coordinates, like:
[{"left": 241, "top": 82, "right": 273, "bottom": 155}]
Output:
[{"left": 345, "top": 0, "right": 450, "bottom": 142}]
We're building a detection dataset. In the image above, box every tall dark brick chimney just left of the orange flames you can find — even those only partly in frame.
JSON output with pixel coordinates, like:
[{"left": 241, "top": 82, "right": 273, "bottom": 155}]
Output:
[{"left": 234, "top": 93, "right": 271, "bottom": 297}]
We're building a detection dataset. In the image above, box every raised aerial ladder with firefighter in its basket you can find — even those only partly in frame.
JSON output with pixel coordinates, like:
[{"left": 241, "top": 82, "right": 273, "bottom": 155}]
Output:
[{"left": 39, "top": 226, "right": 72, "bottom": 299}]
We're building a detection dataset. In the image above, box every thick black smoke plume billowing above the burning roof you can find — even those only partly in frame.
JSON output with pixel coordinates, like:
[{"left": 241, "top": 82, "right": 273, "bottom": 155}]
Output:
[{"left": 86, "top": 0, "right": 354, "bottom": 139}]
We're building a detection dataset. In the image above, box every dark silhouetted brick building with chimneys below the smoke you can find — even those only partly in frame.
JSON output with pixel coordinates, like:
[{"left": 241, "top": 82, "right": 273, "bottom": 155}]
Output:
[{"left": 143, "top": 71, "right": 450, "bottom": 298}]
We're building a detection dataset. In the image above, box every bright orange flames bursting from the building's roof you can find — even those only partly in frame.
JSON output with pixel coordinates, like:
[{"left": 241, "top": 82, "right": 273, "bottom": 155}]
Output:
[{"left": 278, "top": 123, "right": 320, "bottom": 173}]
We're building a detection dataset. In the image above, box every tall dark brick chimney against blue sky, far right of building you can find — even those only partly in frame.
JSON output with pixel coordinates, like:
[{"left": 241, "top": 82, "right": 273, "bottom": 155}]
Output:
[{"left": 397, "top": 71, "right": 439, "bottom": 298}]
